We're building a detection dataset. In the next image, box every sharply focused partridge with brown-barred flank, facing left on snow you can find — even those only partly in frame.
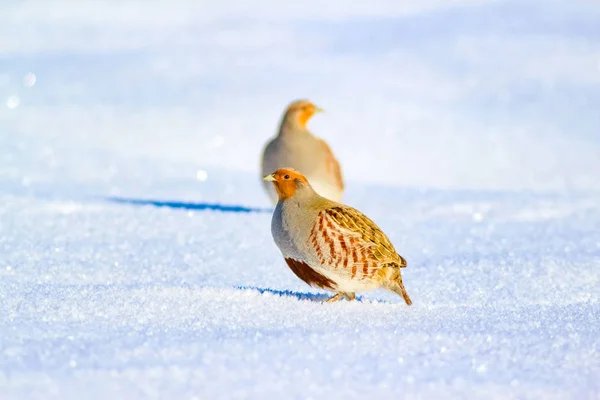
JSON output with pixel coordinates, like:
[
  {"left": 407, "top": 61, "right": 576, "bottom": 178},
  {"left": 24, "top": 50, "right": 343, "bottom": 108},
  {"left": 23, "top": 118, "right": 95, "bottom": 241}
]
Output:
[{"left": 263, "top": 168, "right": 412, "bottom": 305}]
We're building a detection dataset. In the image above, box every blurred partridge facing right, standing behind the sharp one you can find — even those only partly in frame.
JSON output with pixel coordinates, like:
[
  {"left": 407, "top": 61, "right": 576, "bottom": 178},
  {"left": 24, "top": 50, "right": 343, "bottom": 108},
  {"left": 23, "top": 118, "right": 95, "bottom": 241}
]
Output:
[{"left": 261, "top": 100, "right": 344, "bottom": 204}]
